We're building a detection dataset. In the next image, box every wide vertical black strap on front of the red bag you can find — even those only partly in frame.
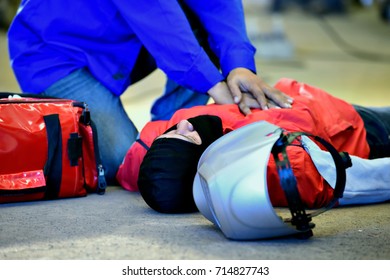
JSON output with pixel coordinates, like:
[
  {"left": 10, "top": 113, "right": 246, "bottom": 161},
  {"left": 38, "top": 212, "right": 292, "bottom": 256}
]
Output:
[{"left": 43, "top": 114, "right": 62, "bottom": 199}]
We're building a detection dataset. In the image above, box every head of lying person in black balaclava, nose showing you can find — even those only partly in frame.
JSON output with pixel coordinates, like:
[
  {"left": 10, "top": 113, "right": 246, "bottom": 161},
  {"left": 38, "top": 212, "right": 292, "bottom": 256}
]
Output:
[{"left": 138, "top": 115, "right": 223, "bottom": 213}]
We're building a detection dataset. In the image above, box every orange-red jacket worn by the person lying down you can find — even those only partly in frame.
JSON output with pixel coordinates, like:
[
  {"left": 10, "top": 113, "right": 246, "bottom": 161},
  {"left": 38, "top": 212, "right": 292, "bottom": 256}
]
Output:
[{"left": 117, "top": 78, "right": 369, "bottom": 208}]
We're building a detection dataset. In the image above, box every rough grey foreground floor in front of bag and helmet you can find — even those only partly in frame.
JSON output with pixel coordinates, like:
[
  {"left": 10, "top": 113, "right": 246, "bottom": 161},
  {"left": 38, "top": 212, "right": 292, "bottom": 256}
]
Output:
[{"left": 0, "top": 187, "right": 390, "bottom": 260}]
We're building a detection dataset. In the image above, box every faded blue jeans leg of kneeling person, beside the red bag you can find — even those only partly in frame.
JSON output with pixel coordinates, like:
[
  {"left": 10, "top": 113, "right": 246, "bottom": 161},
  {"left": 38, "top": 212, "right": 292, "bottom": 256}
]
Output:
[{"left": 44, "top": 69, "right": 138, "bottom": 185}]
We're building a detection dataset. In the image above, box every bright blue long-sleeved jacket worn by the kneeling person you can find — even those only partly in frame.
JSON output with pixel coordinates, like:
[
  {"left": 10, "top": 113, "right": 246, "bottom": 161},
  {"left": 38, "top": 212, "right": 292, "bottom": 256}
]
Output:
[{"left": 8, "top": 0, "right": 256, "bottom": 95}]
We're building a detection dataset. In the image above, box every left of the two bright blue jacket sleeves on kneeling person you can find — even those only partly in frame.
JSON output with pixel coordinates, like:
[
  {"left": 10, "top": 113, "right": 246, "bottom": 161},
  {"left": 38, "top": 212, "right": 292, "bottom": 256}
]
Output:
[{"left": 113, "top": 0, "right": 224, "bottom": 93}]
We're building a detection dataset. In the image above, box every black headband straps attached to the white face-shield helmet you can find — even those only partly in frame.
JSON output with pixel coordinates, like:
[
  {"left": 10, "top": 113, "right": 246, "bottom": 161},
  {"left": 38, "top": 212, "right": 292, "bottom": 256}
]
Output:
[{"left": 271, "top": 131, "right": 352, "bottom": 239}]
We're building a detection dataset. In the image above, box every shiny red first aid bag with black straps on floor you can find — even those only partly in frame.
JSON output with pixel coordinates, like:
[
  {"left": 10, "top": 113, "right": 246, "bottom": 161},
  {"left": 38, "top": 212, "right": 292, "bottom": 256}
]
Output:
[{"left": 0, "top": 93, "right": 106, "bottom": 203}]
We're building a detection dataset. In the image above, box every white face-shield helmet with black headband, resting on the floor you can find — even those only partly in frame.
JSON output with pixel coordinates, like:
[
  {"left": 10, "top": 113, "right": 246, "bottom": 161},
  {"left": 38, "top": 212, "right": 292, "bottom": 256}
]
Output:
[{"left": 193, "top": 121, "right": 350, "bottom": 240}]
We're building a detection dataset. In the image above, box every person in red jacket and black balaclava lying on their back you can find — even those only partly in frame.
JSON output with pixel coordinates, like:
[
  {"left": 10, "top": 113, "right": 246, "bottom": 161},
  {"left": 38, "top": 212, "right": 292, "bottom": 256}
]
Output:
[{"left": 117, "top": 79, "right": 390, "bottom": 213}]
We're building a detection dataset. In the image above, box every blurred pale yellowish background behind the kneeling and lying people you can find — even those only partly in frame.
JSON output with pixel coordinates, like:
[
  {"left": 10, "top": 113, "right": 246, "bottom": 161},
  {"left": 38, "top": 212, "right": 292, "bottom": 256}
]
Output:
[{"left": 0, "top": 0, "right": 390, "bottom": 129}]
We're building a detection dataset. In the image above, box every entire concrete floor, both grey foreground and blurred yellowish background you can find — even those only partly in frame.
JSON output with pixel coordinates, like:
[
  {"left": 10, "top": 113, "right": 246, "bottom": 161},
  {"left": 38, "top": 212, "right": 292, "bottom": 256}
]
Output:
[{"left": 0, "top": 1, "right": 390, "bottom": 260}]
